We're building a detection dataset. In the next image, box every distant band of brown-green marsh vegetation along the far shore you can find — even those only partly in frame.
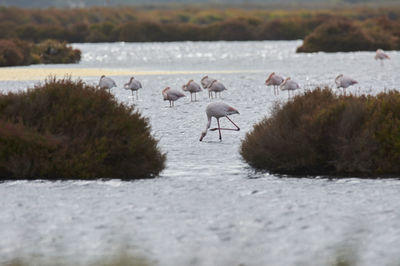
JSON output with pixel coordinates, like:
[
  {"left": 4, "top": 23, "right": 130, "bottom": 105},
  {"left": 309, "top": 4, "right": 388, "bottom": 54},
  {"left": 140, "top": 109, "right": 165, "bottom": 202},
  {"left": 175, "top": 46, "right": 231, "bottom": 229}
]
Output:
[{"left": 0, "top": 5, "right": 400, "bottom": 52}]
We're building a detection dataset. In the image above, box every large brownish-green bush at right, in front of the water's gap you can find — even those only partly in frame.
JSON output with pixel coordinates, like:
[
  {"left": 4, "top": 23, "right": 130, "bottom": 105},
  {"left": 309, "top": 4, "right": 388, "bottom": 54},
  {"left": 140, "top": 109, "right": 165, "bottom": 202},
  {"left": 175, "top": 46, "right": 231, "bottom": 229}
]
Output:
[{"left": 241, "top": 88, "right": 400, "bottom": 177}]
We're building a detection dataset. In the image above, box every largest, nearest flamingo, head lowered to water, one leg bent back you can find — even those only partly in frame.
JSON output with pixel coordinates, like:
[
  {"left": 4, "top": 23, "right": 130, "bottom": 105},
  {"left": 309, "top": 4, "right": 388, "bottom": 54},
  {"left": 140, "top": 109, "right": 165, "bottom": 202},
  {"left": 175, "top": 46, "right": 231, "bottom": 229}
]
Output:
[{"left": 200, "top": 102, "right": 240, "bottom": 141}]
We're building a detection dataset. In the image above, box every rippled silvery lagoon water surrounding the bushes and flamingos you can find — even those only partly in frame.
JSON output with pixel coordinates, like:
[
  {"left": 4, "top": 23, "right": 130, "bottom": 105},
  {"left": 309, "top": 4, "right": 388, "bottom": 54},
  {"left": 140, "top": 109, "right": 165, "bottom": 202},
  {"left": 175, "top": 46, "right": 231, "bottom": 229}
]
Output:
[{"left": 0, "top": 41, "right": 400, "bottom": 266}]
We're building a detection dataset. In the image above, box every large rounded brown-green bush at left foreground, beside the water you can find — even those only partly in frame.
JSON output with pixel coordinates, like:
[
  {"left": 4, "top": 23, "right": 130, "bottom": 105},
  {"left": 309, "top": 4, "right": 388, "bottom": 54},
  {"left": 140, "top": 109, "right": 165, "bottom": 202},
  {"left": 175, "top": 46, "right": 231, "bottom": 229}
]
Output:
[{"left": 0, "top": 78, "right": 165, "bottom": 180}]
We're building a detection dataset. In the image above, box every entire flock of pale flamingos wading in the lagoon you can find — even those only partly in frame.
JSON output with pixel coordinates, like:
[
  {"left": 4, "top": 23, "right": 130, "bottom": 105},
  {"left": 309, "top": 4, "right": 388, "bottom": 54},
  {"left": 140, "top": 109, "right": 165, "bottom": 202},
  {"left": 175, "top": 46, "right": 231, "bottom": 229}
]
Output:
[{"left": 98, "top": 49, "right": 390, "bottom": 141}]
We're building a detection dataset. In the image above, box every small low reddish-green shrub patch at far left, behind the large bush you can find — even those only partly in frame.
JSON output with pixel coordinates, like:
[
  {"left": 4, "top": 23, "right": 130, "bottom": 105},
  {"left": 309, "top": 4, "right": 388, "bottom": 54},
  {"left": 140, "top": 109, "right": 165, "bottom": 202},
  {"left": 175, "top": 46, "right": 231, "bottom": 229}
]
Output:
[{"left": 0, "top": 39, "right": 81, "bottom": 66}]
